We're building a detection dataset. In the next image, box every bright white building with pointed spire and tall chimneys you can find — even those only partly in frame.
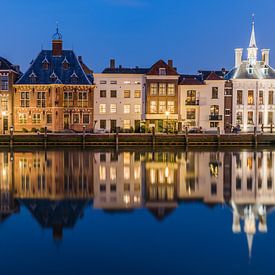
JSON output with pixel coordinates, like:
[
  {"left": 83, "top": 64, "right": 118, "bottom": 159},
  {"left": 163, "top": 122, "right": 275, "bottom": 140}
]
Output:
[{"left": 226, "top": 19, "right": 275, "bottom": 132}]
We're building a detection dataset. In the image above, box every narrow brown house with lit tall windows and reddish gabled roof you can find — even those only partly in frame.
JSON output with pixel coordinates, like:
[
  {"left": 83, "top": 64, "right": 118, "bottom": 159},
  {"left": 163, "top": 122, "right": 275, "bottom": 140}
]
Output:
[{"left": 145, "top": 60, "right": 179, "bottom": 132}]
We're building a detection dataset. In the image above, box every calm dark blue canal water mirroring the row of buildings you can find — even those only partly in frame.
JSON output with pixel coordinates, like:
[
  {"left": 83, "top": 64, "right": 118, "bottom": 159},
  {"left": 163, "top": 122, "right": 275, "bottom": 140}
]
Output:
[{"left": 0, "top": 149, "right": 275, "bottom": 274}]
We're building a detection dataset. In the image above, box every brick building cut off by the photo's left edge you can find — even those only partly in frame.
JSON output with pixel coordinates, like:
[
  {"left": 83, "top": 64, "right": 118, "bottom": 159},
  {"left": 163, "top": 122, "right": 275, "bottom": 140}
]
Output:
[{"left": 0, "top": 57, "right": 21, "bottom": 134}]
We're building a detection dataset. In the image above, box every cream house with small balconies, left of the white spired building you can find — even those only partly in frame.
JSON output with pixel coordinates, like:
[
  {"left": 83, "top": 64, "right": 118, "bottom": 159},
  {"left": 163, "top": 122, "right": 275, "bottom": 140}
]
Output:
[{"left": 179, "top": 70, "right": 228, "bottom": 131}]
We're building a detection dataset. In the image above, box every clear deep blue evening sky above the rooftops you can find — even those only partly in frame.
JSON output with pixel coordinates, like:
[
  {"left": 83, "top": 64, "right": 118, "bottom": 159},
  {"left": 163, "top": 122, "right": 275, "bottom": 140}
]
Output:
[{"left": 0, "top": 0, "right": 275, "bottom": 73}]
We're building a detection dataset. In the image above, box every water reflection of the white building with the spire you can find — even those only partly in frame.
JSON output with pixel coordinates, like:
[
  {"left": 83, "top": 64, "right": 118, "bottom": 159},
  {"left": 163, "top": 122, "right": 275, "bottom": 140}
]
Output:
[{"left": 231, "top": 152, "right": 275, "bottom": 255}]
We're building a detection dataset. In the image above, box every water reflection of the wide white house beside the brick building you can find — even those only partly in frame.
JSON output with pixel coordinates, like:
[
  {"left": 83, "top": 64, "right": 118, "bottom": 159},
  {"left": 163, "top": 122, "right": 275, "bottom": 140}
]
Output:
[{"left": 94, "top": 152, "right": 142, "bottom": 210}]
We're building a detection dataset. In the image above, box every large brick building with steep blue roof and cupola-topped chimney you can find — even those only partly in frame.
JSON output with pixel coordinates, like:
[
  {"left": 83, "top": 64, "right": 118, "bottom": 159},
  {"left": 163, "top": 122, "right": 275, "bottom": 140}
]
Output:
[{"left": 14, "top": 29, "right": 94, "bottom": 132}]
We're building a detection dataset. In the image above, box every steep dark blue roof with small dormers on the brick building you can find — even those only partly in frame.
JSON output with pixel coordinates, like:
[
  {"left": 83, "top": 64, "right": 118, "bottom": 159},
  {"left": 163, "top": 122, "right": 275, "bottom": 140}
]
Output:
[{"left": 16, "top": 50, "right": 93, "bottom": 85}]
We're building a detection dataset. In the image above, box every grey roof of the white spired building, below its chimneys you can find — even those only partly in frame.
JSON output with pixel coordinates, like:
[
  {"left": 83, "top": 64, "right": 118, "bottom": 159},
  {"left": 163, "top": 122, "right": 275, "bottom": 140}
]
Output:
[{"left": 225, "top": 61, "right": 275, "bottom": 80}]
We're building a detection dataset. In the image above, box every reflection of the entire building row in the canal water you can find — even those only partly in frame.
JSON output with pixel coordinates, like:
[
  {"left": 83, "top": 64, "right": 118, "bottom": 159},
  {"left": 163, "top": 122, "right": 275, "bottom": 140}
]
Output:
[{"left": 0, "top": 151, "right": 275, "bottom": 255}]
